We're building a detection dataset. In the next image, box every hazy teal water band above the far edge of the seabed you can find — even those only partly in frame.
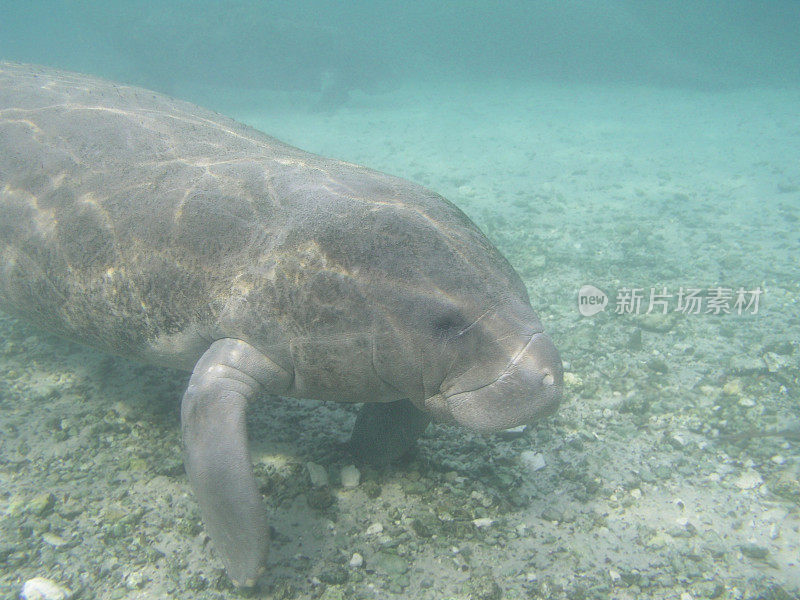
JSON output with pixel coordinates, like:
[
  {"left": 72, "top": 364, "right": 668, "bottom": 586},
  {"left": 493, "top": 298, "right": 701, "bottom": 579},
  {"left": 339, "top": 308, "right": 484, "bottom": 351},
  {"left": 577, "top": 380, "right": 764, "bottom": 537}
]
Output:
[{"left": 0, "top": 0, "right": 800, "bottom": 91}]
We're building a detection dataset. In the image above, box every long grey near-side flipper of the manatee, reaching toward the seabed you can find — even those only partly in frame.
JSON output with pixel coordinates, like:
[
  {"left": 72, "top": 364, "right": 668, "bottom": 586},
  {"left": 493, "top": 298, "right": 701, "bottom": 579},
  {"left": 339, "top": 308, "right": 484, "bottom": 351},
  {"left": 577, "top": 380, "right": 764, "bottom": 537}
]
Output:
[{"left": 181, "top": 339, "right": 292, "bottom": 586}]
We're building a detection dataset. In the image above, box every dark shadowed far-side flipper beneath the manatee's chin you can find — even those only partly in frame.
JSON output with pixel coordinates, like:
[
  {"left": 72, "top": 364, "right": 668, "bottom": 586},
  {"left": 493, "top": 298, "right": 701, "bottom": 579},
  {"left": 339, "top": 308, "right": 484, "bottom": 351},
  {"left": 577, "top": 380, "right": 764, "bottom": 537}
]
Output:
[{"left": 350, "top": 400, "right": 431, "bottom": 466}]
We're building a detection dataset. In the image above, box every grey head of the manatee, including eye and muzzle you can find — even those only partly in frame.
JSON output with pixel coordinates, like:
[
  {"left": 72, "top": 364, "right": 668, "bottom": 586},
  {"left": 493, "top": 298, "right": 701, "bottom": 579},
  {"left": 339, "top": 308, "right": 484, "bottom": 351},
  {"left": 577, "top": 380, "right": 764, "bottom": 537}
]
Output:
[{"left": 298, "top": 166, "right": 563, "bottom": 432}]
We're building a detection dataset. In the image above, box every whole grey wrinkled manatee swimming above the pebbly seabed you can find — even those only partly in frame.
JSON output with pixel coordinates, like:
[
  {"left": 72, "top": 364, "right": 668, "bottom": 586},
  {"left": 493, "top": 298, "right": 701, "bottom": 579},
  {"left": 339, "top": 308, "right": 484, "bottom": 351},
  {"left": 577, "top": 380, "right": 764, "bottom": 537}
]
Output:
[{"left": 0, "top": 63, "right": 562, "bottom": 585}]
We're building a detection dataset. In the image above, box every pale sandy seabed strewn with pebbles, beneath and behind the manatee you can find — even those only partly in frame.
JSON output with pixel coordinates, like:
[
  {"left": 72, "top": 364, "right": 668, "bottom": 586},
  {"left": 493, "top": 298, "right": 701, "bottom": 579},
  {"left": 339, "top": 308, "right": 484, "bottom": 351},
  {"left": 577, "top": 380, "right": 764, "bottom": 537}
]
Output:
[{"left": 0, "top": 82, "right": 800, "bottom": 600}]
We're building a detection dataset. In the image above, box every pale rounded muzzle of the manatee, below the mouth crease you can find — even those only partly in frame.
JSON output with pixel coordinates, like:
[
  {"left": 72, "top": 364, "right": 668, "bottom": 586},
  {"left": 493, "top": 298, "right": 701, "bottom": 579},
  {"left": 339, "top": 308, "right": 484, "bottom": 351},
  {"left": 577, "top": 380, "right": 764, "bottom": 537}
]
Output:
[{"left": 425, "top": 332, "right": 564, "bottom": 433}]
